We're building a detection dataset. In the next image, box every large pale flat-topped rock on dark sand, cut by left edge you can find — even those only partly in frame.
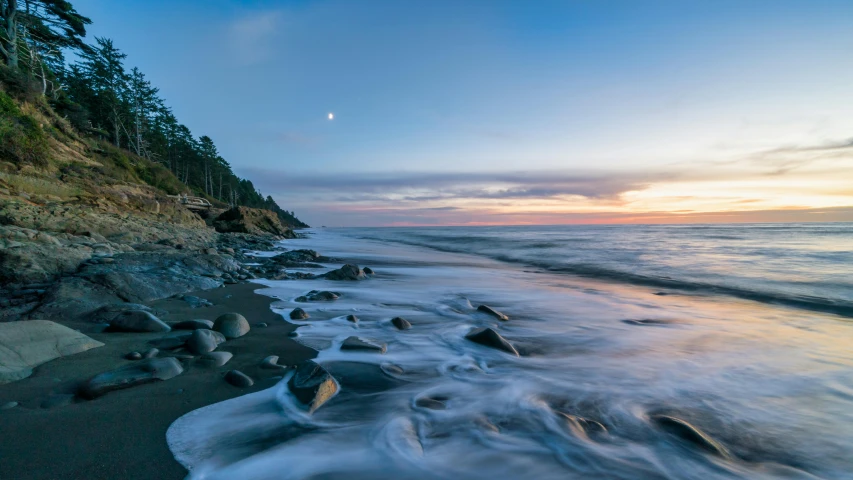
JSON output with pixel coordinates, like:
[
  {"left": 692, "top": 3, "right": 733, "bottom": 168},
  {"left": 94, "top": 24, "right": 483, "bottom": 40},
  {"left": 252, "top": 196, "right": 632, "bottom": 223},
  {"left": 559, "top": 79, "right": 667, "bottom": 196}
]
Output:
[{"left": 0, "top": 320, "right": 104, "bottom": 384}]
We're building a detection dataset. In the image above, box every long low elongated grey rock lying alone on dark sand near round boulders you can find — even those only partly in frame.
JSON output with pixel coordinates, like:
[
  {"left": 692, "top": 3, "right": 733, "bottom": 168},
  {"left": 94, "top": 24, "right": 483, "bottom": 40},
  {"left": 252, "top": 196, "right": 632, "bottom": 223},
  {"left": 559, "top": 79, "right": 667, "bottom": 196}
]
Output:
[{"left": 79, "top": 358, "right": 184, "bottom": 399}]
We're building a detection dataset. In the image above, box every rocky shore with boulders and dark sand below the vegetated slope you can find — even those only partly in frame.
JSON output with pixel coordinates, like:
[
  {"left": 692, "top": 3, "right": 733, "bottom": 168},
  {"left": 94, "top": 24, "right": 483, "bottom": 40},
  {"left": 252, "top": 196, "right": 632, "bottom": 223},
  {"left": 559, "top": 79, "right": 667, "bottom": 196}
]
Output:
[{"left": 0, "top": 197, "right": 365, "bottom": 479}]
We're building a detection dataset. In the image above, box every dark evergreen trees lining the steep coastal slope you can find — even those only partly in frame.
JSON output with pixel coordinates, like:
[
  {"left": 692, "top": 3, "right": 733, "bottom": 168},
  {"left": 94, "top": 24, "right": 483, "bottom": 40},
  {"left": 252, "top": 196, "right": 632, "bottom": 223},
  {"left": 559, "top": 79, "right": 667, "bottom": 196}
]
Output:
[{"left": 0, "top": 0, "right": 307, "bottom": 227}]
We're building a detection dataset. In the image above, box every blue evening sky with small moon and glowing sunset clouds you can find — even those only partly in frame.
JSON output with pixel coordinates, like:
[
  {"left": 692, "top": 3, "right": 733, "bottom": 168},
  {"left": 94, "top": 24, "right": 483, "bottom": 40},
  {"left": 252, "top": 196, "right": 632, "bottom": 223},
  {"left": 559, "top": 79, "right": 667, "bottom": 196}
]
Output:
[{"left": 72, "top": 0, "right": 853, "bottom": 227}]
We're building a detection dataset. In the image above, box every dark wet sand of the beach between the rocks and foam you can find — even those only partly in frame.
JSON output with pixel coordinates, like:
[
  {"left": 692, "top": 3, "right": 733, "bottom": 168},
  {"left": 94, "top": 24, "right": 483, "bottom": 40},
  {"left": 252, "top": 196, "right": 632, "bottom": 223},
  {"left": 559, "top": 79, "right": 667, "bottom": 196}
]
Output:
[{"left": 0, "top": 283, "right": 316, "bottom": 479}]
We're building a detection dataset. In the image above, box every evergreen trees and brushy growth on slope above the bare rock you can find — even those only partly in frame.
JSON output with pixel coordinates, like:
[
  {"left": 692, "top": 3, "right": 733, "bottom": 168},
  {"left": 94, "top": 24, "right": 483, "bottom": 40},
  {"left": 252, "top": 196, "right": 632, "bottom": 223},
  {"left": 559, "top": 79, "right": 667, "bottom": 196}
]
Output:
[{"left": 0, "top": 0, "right": 307, "bottom": 227}]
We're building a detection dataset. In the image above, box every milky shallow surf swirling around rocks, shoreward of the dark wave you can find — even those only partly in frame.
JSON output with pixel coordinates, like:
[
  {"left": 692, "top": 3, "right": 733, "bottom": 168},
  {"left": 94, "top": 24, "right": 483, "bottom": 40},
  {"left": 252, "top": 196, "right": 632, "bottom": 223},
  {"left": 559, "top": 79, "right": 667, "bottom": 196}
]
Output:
[{"left": 168, "top": 230, "right": 853, "bottom": 479}]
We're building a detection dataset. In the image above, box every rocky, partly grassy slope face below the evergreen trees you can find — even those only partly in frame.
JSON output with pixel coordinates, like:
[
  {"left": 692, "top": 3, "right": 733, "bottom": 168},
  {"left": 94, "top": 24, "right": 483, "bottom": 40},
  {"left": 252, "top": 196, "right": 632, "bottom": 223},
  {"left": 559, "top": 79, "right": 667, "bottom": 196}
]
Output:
[{"left": 0, "top": 85, "right": 300, "bottom": 321}]
